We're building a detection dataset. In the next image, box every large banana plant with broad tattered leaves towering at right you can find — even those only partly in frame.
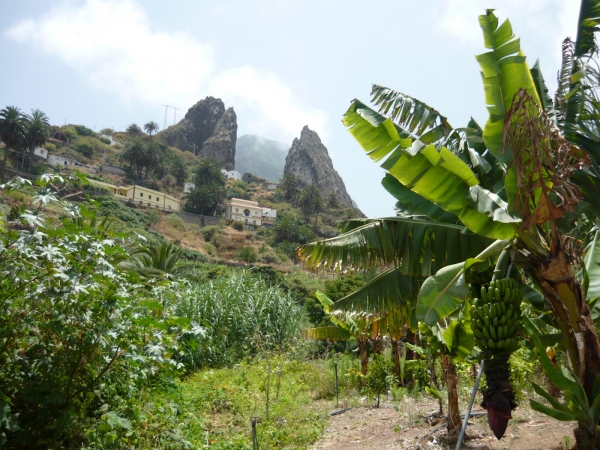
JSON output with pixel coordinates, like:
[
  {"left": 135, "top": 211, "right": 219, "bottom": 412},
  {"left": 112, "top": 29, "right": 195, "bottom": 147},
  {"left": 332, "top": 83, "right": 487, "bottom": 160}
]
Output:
[{"left": 304, "top": 4, "right": 600, "bottom": 450}]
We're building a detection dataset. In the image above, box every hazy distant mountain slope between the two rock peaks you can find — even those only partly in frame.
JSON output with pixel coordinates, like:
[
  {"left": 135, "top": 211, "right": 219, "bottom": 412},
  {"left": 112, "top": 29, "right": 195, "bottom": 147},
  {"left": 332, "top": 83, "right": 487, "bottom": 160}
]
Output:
[{"left": 235, "top": 134, "right": 290, "bottom": 181}]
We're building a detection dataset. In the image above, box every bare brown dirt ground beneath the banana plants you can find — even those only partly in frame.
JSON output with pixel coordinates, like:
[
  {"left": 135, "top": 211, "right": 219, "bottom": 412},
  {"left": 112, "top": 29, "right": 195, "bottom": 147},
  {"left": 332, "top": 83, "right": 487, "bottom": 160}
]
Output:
[{"left": 313, "top": 404, "right": 574, "bottom": 450}]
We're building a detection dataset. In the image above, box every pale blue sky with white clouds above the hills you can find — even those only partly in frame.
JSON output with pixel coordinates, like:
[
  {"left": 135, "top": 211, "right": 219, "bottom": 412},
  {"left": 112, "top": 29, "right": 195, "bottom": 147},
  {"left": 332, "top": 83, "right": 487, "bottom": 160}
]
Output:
[{"left": 0, "top": 0, "right": 579, "bottom": 217}]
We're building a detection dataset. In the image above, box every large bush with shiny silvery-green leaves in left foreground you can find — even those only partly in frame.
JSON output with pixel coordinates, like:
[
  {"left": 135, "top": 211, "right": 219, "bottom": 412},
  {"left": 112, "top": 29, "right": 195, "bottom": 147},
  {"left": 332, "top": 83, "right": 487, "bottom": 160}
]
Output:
[{"left": 0, "top": 177, "right": 189, "bottom": 448}]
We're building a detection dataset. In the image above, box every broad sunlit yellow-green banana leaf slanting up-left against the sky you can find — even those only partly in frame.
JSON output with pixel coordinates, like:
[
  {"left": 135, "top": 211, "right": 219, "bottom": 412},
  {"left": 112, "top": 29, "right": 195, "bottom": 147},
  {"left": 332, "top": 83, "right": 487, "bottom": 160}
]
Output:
[{"left": 344, "top": 100, "right": 520, "bottom": 239}]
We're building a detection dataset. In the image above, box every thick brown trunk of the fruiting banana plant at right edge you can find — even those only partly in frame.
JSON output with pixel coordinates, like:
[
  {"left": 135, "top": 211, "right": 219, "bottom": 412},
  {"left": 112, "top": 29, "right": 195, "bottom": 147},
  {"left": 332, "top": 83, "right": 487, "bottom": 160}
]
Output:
[{"left": 532, "top": 246, "right": 600, "bottom": 450}]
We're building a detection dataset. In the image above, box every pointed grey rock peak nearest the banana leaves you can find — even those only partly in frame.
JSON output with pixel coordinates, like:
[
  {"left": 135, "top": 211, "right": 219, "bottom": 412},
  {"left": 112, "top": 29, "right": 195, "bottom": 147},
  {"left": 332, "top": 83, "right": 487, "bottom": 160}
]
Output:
[{"left": 283, "top": 126, "right": 362, "bottom": 209}]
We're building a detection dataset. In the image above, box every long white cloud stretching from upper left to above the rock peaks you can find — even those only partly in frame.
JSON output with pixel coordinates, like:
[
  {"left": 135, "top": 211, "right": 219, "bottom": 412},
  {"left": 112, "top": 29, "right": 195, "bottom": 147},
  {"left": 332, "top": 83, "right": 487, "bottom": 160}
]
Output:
[{"left": 5, "top": 0, "right": 327, "bottom": 138}]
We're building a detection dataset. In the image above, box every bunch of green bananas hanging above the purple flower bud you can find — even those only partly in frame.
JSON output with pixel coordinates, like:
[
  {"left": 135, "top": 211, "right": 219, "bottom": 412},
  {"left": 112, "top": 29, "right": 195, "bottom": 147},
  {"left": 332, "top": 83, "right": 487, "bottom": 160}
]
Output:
[{"left": 471, "top": 278, "right": 523, "bottom": 351}]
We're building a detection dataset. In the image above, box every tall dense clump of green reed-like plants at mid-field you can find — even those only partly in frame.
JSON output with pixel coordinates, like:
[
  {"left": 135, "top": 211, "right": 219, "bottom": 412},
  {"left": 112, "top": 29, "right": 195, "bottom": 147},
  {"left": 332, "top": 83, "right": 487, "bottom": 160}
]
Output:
[{"left": 159, "top": 272, "right": 307, "bottom": 369}]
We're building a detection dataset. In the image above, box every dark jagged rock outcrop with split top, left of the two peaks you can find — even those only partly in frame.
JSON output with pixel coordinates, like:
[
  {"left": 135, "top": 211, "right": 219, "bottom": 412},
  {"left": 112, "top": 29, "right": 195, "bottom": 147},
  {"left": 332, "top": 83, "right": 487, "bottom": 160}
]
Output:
[{"left": 157, "top": 97, "right": 237, "bottom": 170}]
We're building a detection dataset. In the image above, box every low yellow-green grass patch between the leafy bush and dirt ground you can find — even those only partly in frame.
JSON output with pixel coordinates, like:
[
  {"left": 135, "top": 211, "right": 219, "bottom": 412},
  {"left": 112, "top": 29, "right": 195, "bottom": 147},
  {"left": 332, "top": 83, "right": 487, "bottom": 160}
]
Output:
[{"left": 181, "top": 357, "right": 335, "bottom": 450}]
